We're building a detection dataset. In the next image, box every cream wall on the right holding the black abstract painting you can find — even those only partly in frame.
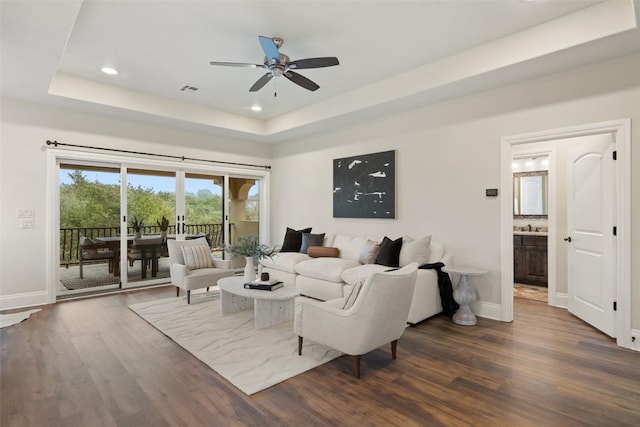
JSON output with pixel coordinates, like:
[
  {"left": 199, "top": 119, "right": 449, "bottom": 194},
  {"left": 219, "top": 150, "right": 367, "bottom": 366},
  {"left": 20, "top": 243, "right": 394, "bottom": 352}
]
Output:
[{"left": 271, "top": 51, "right": 640, "bottom": 329}]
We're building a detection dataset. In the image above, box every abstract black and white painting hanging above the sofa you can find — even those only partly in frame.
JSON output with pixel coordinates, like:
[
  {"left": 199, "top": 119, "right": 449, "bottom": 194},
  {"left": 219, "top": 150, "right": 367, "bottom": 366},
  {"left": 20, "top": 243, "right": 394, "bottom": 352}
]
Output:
[{"left": 333, "top": 150, "right": 396, "bottom": 218}]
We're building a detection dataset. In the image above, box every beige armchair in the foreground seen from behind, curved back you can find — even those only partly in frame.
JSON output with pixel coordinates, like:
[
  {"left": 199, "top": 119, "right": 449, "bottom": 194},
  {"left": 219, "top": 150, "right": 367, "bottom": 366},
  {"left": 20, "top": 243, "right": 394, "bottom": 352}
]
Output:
[{"left": 293, "top": 263, "right": 418, "bottom": 378}]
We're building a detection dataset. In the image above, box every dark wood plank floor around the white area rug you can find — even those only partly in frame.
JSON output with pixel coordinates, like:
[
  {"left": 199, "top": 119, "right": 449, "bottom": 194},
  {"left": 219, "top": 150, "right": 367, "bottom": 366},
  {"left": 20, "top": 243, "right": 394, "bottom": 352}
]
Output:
[{"left": 0, "top": 287, "right": 640, "bottom": 427}]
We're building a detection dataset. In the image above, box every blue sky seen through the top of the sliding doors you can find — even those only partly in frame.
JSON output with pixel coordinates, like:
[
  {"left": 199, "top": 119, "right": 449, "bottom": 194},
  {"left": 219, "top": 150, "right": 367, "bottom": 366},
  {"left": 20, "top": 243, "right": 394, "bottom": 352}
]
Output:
[{"left": 60, "top": 169, "right": 258, "bottom": 196}]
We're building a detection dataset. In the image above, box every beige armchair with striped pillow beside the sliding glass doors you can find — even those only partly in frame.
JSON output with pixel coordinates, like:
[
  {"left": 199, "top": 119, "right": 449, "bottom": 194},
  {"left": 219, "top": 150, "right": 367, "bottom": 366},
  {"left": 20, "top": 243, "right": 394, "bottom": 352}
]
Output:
[{"left": 167, "top": 237, "right": 234, "bottom": 304}]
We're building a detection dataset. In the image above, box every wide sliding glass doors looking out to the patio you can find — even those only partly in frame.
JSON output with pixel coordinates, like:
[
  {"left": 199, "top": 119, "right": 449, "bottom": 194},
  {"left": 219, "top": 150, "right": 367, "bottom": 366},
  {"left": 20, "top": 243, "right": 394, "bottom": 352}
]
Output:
[{"left": 54, "top": 154, "right": 268, "bottom": 297}]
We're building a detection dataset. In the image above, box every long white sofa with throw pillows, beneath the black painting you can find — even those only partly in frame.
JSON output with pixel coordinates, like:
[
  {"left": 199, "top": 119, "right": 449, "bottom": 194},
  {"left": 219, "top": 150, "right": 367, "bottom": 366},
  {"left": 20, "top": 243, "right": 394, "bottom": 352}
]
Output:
[{"left": 261, "top": 234, "right": 453, "bottom": 324}]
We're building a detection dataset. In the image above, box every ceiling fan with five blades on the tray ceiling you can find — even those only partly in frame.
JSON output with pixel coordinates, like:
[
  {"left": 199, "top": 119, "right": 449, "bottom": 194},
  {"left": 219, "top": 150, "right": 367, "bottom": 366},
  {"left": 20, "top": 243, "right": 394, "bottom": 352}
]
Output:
[{"left": 209, "top": 36, "right": 340, "bottom": 92}]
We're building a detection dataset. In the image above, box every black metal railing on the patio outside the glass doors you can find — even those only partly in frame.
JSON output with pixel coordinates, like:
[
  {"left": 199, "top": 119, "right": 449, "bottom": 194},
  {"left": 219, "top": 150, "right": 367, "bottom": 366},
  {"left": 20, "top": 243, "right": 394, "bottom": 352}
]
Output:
[{"left": 60, "top": 224, "right": 224, "bottom": 266}]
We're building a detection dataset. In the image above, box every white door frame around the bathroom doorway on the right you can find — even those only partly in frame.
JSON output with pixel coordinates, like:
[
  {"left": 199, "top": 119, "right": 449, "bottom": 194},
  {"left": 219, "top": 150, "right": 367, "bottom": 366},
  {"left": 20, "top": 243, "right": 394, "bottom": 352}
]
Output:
[{"left": 500, "top": 119, "right": 633, "bottom": 348}]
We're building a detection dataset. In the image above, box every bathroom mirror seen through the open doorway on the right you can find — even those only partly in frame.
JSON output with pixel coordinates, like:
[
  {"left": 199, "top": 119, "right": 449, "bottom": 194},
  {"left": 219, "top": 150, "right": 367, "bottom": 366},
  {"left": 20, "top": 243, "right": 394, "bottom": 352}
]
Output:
[{"left": 513, "top": 171, "right": 549, "bottom": 218}]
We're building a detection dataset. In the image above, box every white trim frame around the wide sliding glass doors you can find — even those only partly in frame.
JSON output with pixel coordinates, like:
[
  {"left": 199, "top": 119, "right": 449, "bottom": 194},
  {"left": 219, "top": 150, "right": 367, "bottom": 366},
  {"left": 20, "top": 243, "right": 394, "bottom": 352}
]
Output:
[{"left": 45, "top": 148, "right": 270, "bottom": 304}]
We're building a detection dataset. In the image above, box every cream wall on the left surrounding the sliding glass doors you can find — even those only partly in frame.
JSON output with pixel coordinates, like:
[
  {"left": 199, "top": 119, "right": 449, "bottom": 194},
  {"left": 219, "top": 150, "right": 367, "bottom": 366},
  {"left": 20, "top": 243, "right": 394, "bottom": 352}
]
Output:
[{"left": 0, "top": 98, "right": 271, "bottom": 309}]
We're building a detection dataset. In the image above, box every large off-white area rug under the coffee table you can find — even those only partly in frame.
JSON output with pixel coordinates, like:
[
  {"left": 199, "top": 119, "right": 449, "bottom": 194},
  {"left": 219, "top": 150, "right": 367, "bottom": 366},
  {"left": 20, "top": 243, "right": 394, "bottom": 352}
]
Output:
[{"left": 129, "top": 292, "right": 341, "bottom": 394}]
